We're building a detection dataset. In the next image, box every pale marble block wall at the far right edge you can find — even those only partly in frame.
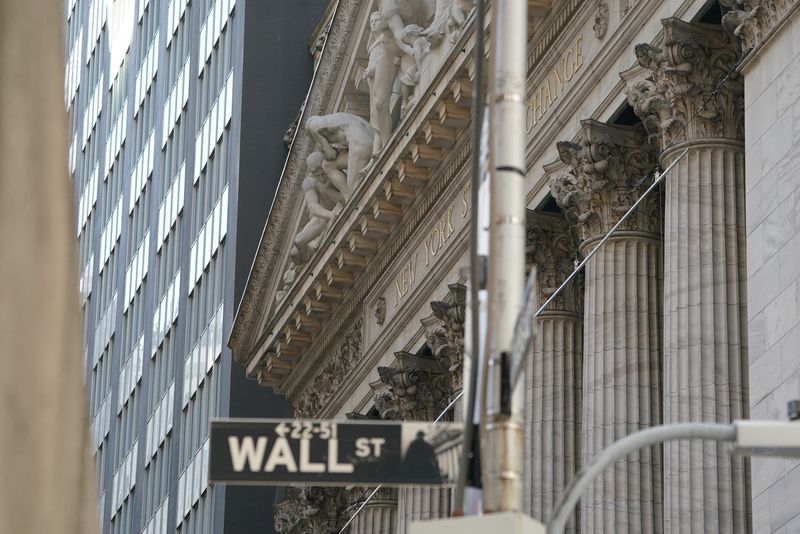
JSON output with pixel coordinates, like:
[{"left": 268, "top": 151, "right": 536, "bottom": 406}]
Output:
[{"left": 744, "top": 11, "right": 800, "bottom": 534}]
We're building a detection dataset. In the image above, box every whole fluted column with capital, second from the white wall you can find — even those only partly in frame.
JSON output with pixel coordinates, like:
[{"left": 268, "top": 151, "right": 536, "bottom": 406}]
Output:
[{"left": 550, "top": 120, "right": 662, "bottom": 533}]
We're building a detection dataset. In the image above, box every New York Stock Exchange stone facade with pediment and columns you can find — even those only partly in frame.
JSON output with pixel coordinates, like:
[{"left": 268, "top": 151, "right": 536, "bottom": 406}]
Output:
[{"left": 231, "top": 0, "right": 800, "bottom": 534}]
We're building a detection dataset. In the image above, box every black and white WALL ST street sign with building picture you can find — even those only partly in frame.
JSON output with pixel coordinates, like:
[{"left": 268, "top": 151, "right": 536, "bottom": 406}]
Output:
[{"left": 209, "top": 419, "right": 464, "bottom": 486}]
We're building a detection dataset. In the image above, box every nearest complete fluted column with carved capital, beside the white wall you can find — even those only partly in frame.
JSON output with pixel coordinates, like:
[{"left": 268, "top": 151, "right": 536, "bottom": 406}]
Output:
[{"left": 623, "top": 19, "right": 751, "bottom": 533}]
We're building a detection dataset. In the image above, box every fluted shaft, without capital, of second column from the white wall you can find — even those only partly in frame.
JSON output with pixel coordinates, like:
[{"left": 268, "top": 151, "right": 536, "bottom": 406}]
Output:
[{"left": 581, "top": 237, "right": 662, "bottom": 533}]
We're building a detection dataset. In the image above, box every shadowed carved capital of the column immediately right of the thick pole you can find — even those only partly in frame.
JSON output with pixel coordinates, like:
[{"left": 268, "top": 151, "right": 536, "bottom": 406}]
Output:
[{"left": 525, "top": 210, "right": 583, "bottom": 313}]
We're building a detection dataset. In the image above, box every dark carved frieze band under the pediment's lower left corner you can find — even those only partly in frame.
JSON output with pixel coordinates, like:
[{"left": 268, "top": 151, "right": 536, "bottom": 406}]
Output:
[{"left": 292, "top": 316, "right": 363, "bottom": 418}]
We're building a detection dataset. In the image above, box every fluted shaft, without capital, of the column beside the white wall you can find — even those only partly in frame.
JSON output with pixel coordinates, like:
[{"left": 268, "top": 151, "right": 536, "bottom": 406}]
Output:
[{"left": 664, "top": 140, "right": 750, "bottom": 533}]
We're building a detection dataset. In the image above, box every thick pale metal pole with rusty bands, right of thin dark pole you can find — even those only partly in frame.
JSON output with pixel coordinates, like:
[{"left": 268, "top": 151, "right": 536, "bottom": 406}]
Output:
[{"left": 481, "top": 0, "right": 528, "bottom": 512}]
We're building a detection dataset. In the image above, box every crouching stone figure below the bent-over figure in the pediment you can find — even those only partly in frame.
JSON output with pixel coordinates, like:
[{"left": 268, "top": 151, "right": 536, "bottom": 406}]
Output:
[{"left": 292, "top": 152, "right": 346, "bottom": 263}]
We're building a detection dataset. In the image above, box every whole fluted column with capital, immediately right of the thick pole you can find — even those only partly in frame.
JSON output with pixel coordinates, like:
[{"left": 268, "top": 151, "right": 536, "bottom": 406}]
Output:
[{"left": 525, "top": 212, "right": 583, "bottom": 533}]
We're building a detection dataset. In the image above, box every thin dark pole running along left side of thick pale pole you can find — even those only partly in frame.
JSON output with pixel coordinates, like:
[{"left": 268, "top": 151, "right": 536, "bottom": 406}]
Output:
[{"left": 453, "top": 0, "right": 486, "bottom": 516}]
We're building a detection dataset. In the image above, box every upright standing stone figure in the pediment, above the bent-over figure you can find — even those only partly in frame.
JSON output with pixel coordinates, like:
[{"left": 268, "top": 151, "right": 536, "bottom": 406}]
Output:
[{"left": 363, "top": 11, "right": 404, "bottom": 155}]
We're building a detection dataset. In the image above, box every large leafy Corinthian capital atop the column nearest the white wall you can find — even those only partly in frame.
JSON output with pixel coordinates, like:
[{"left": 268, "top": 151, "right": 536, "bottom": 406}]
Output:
[{"left": 621, "top": 18, "right": 744, "bottom": 149}]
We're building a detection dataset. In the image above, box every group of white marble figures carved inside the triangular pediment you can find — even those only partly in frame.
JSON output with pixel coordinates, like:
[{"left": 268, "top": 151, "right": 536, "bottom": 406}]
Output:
[{"left": 276, "top": 0, "right": 474, "bottom": 302}]
